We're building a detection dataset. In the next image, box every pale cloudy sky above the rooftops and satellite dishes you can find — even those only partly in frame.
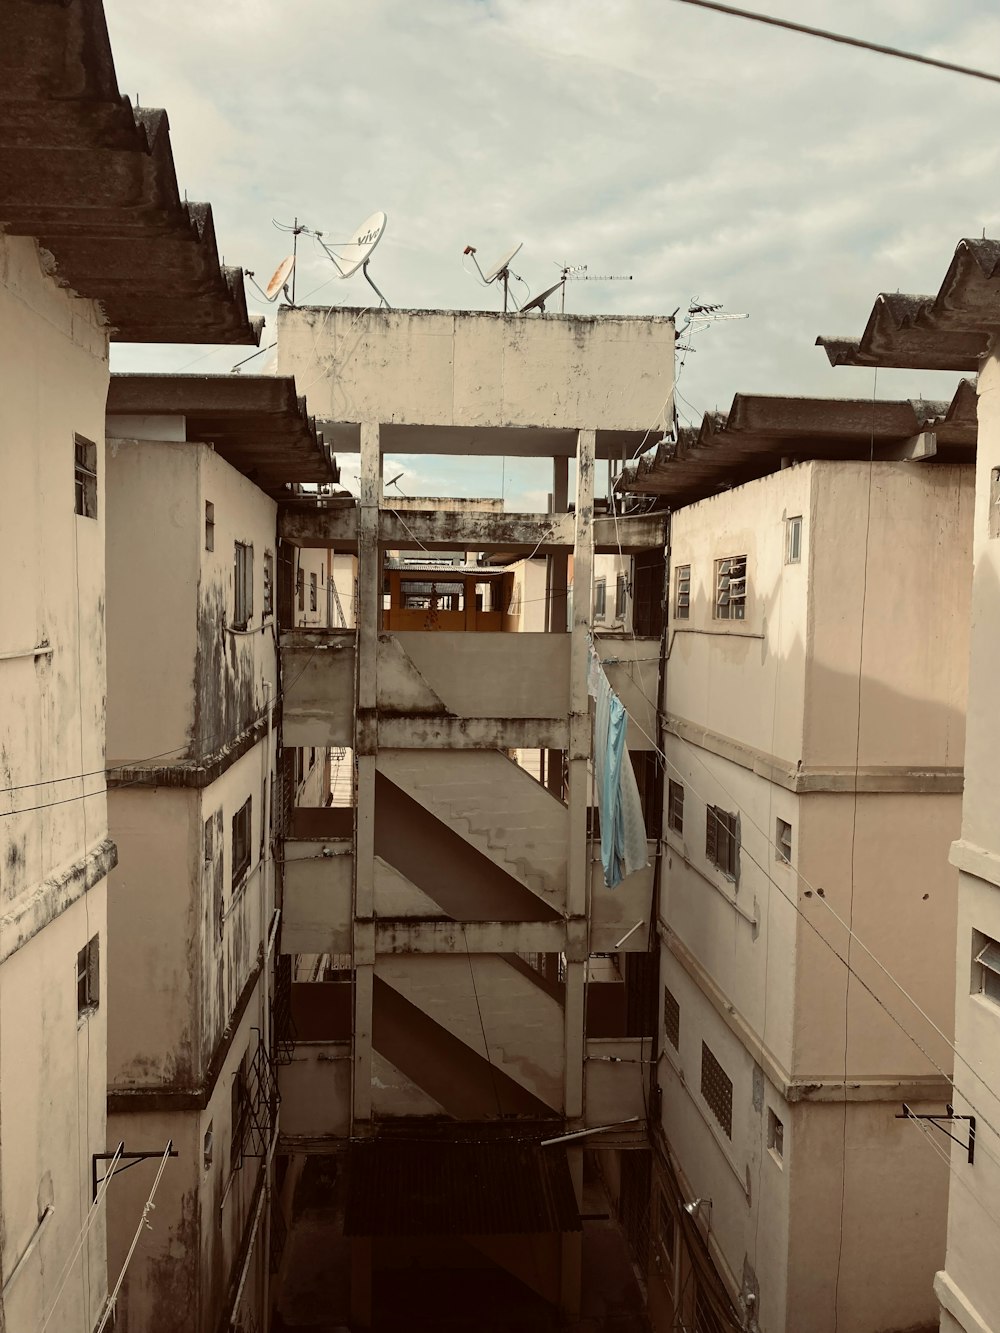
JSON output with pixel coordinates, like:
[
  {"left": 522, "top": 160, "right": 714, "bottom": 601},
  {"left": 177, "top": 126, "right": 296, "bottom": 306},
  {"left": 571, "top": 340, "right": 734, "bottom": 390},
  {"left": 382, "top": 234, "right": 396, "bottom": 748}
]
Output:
[{"left": 105, "top": 0, "right": 1000, "bottom": 501}]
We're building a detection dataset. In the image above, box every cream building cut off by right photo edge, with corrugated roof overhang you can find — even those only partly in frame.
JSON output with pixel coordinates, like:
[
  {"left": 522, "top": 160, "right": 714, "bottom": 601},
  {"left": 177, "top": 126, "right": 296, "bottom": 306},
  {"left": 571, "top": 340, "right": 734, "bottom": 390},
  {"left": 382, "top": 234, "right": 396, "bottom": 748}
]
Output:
[{"left": 820, "top": 240, "right": 1000, "bottom": 1333}]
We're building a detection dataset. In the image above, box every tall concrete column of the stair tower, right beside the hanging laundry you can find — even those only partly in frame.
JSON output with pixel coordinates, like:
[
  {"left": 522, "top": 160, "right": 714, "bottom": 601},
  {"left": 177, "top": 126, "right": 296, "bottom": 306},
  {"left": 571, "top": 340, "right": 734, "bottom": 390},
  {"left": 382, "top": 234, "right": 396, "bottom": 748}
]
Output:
[{"left": 564, "top": 431, "right": 596, "bottom": 1120}]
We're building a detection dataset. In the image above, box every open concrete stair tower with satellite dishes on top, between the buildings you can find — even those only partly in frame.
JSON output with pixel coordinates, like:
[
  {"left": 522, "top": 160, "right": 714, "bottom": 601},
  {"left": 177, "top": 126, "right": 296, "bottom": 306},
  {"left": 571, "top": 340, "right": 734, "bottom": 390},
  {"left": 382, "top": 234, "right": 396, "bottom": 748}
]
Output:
[{"left": 272, "top": 309, "right": 673, "bottom": 1328}]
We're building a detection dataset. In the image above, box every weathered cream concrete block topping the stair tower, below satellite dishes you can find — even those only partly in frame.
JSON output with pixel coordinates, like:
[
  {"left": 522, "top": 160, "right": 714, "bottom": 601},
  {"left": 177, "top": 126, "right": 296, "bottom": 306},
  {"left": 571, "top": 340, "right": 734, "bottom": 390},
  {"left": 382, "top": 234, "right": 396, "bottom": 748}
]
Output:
[{"left": 277, "top": 307, "right": 673, "bottom": 431}]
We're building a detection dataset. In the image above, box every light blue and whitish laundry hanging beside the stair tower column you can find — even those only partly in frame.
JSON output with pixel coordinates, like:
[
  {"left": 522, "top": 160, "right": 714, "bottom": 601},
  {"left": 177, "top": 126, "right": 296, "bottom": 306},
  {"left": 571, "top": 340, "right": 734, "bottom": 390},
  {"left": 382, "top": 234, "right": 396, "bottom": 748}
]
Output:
[{"left": 587, "top": 648, "right": 648, "bottom": 889}]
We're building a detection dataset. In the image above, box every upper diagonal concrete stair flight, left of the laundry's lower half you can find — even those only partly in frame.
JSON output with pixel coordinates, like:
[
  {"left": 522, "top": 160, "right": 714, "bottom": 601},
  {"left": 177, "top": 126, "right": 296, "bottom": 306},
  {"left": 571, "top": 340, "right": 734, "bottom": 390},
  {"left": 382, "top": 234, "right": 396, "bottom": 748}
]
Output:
[{"left": 377, "top": 750, "right": 568, "bottom": 912}]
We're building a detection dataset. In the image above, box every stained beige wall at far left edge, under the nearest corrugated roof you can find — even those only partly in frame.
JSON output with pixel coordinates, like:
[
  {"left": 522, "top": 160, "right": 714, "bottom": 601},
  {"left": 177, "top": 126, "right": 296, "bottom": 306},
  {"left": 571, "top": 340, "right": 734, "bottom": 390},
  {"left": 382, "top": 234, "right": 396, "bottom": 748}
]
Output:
[{"left": 0, "top": 235, "right": 113, "bottom": 1333}]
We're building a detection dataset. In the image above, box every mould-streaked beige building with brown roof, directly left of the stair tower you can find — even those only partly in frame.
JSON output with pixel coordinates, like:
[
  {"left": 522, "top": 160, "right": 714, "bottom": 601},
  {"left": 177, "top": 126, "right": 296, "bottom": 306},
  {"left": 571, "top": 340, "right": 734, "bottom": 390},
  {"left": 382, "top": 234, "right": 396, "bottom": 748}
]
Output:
[{"left": 100, "top": 376, "right": 336, "bottom": 1333}]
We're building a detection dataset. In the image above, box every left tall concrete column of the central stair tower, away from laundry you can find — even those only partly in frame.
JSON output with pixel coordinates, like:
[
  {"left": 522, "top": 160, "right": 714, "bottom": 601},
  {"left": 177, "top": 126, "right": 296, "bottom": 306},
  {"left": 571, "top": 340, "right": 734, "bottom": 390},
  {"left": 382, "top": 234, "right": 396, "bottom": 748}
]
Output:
[{"left": 352, "top": 421, "right": 381, "bottom": 1124}]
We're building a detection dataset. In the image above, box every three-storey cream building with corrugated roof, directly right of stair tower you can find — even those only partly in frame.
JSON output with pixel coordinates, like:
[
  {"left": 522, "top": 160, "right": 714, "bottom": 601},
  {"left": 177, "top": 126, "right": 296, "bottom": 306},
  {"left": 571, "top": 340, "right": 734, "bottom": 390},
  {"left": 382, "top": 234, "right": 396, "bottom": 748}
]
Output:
[{"left": 625, "top": 381, "right": 976, "bottom": 1333}]
